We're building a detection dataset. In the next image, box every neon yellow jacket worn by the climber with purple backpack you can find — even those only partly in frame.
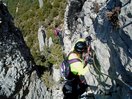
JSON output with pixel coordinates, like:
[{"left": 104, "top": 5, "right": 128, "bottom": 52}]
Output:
[{"left": 68, "top": 53, "right": 88, "bottom": 75}]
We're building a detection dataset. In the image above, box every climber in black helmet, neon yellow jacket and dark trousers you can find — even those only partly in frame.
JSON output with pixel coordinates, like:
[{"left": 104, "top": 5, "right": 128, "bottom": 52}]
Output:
[{"left": 62, "top": 39, "right": 88, "bottom": 99}]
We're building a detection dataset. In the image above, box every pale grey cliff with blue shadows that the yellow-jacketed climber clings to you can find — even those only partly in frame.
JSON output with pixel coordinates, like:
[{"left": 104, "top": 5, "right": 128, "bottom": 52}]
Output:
[{"left": 64, "top": 0, "right": 132, "bottom": 99}]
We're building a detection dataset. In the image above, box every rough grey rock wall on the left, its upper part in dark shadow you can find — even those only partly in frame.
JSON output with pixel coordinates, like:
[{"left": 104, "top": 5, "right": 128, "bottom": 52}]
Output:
[{"left": 0, "top": 2, "right": 51, "bottom": 99}]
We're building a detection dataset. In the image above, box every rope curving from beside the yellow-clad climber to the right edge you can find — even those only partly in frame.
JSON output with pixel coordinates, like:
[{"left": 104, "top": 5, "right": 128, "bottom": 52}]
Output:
[{"left": 90, "top": 52, "right": 132, "bottom": 91}]
